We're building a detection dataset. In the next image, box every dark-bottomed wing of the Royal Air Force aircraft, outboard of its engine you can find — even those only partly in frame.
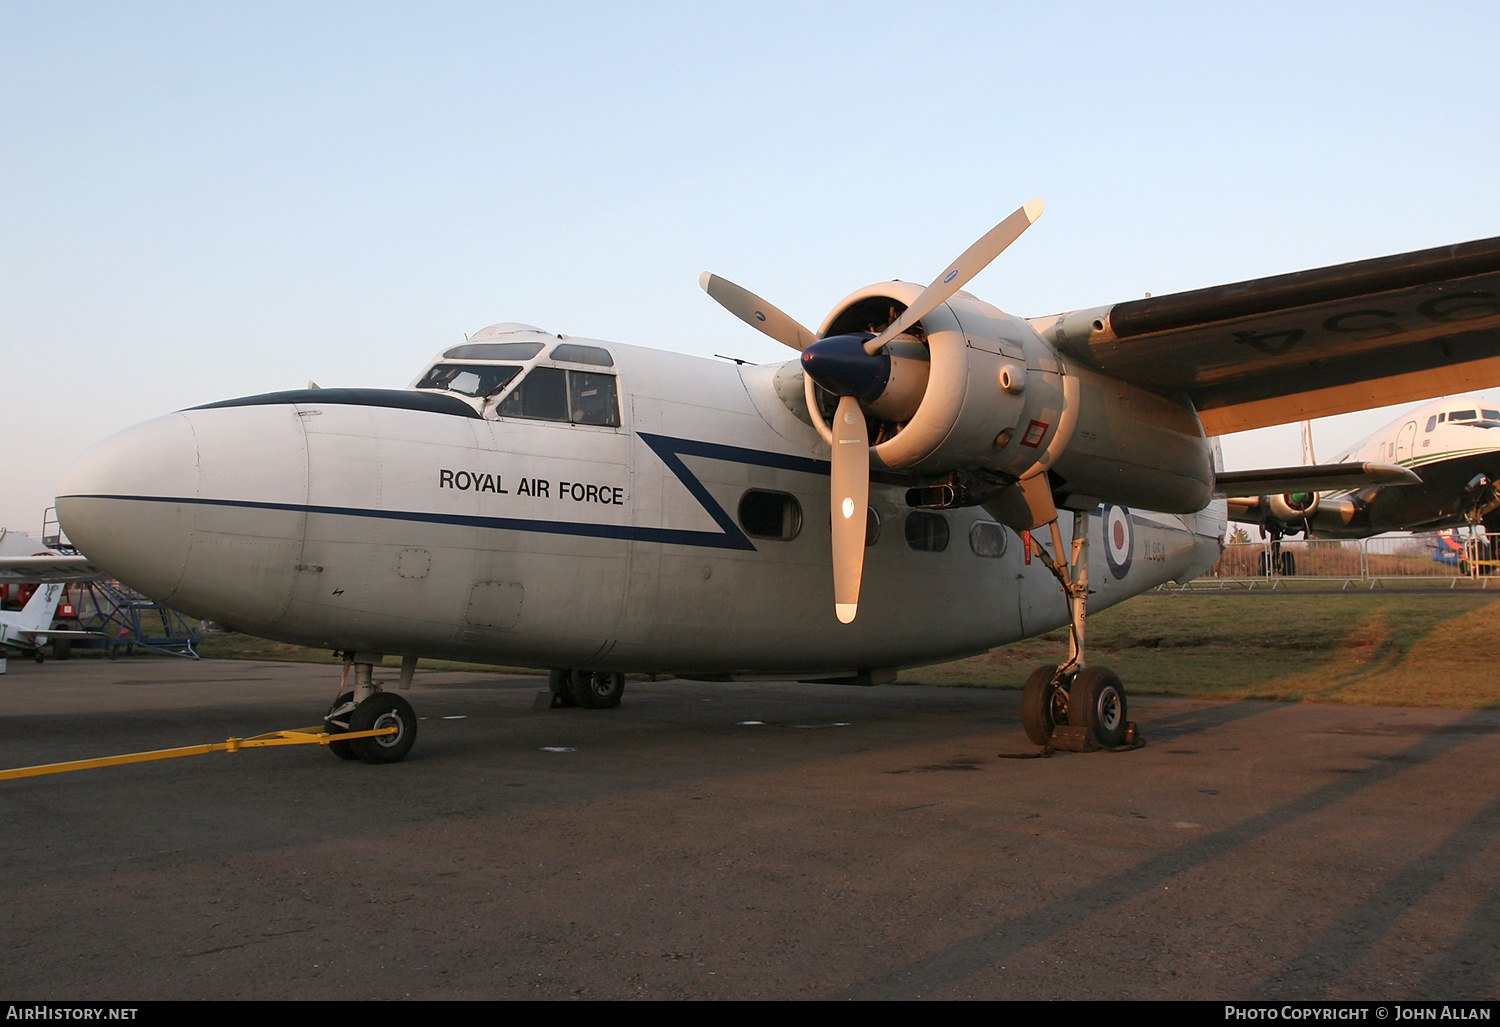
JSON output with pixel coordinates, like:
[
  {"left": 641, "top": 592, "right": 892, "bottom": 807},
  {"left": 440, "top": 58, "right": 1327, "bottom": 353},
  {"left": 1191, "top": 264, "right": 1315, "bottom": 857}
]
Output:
[{"left": 1032, "top": 238, "right": 1500, "bottom": 435}]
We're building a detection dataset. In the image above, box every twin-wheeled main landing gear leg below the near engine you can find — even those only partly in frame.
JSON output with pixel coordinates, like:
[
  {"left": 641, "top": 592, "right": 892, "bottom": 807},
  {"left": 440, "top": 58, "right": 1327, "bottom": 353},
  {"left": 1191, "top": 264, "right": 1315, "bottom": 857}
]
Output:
[{"left": 1022, "top": 513, "right": 1136, "bottom": 751}]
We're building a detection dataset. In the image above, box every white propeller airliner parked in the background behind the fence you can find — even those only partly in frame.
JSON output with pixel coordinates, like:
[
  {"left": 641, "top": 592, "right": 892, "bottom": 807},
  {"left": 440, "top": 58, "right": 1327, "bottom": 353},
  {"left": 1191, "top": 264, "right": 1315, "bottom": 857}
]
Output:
[{"left": 1221, "top": 396, "right": 1500, "bottom": 557}]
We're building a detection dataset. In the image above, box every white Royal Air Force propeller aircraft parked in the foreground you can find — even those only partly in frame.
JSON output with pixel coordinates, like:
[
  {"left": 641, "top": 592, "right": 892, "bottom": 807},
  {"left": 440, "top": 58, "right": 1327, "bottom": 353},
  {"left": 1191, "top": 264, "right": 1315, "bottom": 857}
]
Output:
[{"left": 57, "top": 201, "right": 1500, "bottom": 762}]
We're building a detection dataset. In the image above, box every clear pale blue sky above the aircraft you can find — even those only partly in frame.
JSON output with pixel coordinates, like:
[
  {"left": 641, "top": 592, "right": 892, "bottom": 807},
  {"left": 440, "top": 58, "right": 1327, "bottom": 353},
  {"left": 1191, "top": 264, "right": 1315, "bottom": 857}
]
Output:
[{"left": 0, "top": 0, "right": 1500, "bottom": 532}]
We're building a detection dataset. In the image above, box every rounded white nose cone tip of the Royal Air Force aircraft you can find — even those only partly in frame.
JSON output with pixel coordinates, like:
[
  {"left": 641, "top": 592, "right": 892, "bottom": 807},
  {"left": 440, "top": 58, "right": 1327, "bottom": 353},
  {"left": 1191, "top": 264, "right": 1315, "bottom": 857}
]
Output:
[{"left": 57, "top": 414, "right": 198, "bottom": 600}]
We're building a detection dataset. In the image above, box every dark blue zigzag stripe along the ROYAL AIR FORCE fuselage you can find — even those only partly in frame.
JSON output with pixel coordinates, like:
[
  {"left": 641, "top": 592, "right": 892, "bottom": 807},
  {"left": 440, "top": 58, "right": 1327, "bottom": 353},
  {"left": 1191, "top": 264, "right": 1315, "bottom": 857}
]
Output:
[{"left": 63, "top": 432, "right": 908, "bottom": 552}]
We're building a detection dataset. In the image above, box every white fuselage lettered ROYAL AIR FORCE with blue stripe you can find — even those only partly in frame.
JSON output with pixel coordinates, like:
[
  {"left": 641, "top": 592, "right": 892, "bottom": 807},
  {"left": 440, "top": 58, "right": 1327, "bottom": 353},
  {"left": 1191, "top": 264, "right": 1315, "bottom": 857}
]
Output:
[{"left": 57, "top": 330, "right": 1224, "bottom": 676}]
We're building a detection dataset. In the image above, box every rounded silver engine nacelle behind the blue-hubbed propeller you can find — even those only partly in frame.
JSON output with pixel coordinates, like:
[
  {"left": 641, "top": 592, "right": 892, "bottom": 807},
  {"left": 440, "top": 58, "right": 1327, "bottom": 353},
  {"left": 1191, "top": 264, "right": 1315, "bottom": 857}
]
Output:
[{"left": 809, "top": 282, "right": 1214, "bottom": 513}]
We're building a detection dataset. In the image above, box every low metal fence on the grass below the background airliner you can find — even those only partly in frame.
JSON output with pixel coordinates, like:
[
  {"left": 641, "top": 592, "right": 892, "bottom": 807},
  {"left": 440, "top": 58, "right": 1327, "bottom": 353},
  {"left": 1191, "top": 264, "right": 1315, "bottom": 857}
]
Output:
[{"left": 1163, "top": 535, "right": 1500, "bottom": 589}]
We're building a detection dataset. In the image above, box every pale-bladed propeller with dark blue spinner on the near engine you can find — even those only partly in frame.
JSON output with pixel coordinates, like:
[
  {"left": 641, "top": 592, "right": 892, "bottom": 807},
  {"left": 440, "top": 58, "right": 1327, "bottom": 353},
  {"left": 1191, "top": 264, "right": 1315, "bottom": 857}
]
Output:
[{"left": 698, "top": 199, "right": 1043, "bottom": 624}]
